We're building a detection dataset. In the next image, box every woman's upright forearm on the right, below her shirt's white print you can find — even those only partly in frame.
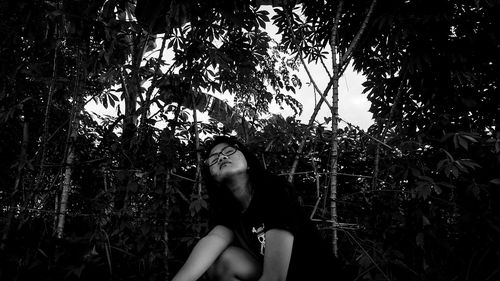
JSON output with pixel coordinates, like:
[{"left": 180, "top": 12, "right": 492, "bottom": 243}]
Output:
[{"left": 259, "top": 229, "right": 294, "bottom": 281}]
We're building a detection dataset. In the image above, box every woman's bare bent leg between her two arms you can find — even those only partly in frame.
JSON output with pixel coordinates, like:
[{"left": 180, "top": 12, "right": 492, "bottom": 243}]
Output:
[{"left": 207, "top": 246, "right": 262, "bottom": 281}]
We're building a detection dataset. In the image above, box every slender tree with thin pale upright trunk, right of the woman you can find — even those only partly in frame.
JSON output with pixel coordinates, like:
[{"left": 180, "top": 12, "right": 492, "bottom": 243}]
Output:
[{"left": 275, "top": 1, "right": 376, "bottom": 255}]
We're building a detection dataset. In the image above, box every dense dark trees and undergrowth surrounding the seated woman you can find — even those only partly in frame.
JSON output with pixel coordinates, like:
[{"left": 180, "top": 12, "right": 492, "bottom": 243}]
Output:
[{"left": 0, "top": 0, "right": 500, "bottom": 281}]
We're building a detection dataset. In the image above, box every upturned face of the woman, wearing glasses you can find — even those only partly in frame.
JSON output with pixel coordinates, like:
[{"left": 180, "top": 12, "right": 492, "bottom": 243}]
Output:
[{"left": 208, "top": 143, "right": 248, "bottom": 182}]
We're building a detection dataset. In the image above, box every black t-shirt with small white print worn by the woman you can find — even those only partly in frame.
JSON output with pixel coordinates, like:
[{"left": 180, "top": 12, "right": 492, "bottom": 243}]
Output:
[{"left": 216, "top": 177, "right": 340, "bottom": 281}]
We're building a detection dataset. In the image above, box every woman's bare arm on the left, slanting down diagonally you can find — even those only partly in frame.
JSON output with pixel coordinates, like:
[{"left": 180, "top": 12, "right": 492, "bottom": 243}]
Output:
[{"left": 172, "top": 225, "right": 234, "bottom": 281}]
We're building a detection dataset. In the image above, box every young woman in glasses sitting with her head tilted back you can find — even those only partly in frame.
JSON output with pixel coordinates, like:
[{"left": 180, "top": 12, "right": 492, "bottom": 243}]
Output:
[{"left": 173, "top": 137, "right": 343, "bottom": 281}]
